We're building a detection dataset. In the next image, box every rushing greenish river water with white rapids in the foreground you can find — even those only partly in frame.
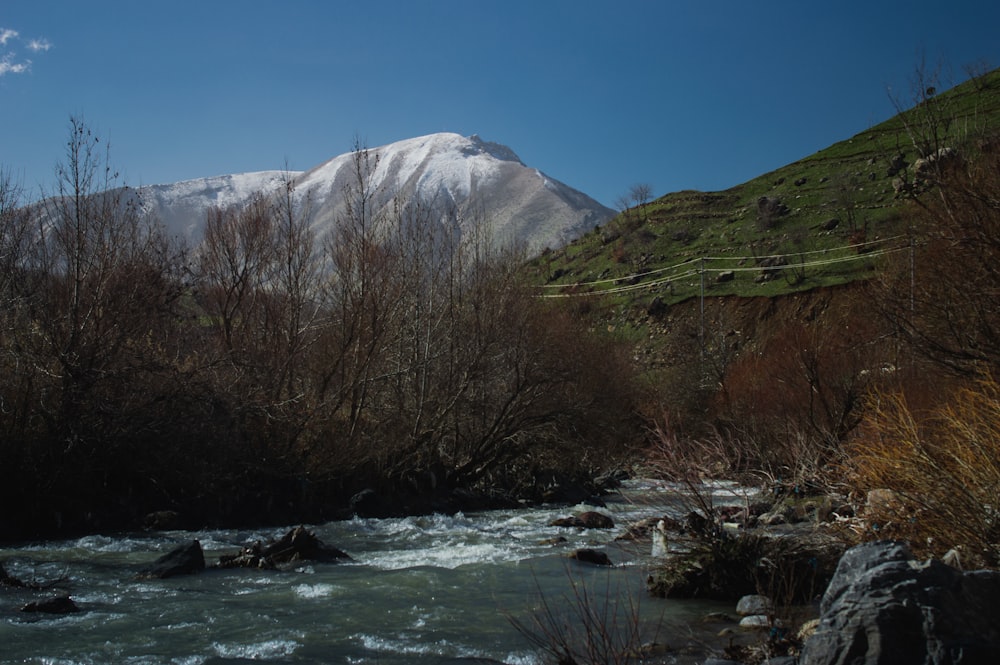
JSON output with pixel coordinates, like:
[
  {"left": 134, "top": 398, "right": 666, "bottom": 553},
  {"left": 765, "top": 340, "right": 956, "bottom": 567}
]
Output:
[{"left": 0, "top": 482, "right": 744, "bottom": 665}]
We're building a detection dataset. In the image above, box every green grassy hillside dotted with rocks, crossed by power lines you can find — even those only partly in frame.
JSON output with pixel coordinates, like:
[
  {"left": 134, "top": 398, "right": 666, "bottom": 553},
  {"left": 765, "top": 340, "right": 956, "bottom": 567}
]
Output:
[{"left": 530, "top": 70, "right": 1000, "bottom": 313}]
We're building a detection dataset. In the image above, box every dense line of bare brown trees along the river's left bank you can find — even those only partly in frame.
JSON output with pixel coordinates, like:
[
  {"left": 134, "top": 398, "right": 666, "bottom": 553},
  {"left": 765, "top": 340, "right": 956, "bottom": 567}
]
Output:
[{"left": 0, "top": 118, "right": 637, "bottom": 537}]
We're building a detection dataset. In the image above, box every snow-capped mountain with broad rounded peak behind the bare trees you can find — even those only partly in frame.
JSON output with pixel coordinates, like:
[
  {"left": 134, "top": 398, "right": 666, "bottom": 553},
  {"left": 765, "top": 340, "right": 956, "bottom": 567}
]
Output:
[{"left": 141, "top": 133, "right": 614, "bottom": 253}]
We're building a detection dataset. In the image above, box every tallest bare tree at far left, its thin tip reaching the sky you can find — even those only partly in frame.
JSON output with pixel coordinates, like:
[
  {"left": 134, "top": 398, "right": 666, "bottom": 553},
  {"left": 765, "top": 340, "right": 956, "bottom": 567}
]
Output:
[{"left": 28, "top": 118, "right": 180, "bottom": 437}]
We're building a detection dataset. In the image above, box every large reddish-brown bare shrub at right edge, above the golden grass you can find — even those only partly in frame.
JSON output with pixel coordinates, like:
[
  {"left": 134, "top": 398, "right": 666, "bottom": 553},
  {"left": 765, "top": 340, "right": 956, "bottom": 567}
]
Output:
[{"left": 873, "top": 136, "right": 1000, "bottom": 376}]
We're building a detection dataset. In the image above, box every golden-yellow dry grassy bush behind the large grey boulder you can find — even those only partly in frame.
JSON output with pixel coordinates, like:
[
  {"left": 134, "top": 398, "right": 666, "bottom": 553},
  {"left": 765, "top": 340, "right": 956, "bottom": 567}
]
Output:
[{"left": 851, "top": 376, "right": 1000, "bottom": 566}]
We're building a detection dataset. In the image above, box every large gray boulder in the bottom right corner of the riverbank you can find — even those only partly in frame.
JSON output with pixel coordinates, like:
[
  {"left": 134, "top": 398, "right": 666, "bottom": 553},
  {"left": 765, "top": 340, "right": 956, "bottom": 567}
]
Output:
[{"left": 800, "top": 541, "right": 1000, "bottom": 665}]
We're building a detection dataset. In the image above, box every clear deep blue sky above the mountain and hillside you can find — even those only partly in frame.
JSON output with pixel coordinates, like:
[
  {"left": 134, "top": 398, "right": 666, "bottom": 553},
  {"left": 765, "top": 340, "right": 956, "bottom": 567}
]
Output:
[{"left": 0, "top": 0, "right": 1000, "bottom": 206}]
